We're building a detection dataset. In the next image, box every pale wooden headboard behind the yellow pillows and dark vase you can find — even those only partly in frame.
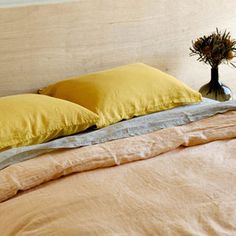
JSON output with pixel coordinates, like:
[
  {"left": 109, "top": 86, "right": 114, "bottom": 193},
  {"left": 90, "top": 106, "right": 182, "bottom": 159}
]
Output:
[{"left": 0, "top": 0, "right": 236, "bottom": 96}]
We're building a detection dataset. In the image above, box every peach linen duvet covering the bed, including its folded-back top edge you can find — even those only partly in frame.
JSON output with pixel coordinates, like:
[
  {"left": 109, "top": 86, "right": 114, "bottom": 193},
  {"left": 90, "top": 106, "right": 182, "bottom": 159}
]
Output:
[{"left": 0, "top": 101, "right": 236, "bottom": 236}]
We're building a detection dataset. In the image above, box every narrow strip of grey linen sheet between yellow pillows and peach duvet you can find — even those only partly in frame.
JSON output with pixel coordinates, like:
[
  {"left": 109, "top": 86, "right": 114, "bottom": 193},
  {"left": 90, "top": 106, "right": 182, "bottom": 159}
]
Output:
[{"left": 0, "top": 99, "right": 236, "bottom": 170}]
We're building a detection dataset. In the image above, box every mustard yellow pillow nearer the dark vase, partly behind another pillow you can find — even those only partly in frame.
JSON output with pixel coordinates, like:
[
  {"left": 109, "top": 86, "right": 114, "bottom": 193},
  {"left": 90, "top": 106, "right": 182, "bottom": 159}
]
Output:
[{"left": 39, "top": 63, "right": 202, "bottom": 127}]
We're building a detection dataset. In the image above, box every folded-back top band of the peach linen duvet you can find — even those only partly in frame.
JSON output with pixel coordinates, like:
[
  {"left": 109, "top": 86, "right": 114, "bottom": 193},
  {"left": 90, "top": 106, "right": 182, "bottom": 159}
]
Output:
[{"left": 0, "top": 111, "right": 236, "bottom": 202}]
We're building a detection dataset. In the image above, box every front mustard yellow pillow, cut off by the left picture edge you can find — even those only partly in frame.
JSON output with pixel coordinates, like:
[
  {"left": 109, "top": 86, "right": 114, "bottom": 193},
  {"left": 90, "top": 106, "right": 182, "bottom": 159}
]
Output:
[{"left": 0, "top": 94, "right": 98, "bottom": 150}]
